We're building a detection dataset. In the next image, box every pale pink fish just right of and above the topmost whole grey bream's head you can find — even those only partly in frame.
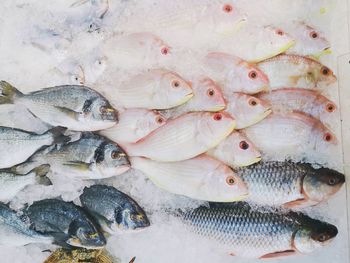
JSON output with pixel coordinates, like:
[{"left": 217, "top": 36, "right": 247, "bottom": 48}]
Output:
[{"left": 113, "top": 69, "right": 193, "bottom": 109}]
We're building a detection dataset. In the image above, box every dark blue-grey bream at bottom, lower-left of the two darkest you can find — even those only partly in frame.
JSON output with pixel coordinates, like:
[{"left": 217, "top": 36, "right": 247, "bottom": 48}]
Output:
[{"left": 23, "top": 199, "right": 106, "bottom": 249}]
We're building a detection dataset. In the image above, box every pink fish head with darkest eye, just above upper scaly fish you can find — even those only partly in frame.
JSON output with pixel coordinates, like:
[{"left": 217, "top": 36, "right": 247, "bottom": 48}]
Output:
[{"left": 225, "top": 131, "right": 261, "bottom": 167}]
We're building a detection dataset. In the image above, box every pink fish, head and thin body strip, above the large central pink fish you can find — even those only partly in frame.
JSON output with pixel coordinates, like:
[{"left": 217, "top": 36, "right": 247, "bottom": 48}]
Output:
[{"left": 162, "top": 77, "right": 226, "bottom": 118}]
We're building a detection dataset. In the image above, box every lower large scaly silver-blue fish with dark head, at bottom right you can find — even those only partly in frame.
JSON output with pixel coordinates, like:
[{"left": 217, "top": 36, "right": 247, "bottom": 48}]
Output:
[{"left": 183, "top": 202, "right": 338, "bottom": 258}]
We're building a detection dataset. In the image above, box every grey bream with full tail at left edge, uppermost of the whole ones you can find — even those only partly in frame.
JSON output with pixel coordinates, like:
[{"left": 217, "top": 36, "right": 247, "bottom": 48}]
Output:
[{"left": 0, "top": 81, "right": 118, "bottom": 131}]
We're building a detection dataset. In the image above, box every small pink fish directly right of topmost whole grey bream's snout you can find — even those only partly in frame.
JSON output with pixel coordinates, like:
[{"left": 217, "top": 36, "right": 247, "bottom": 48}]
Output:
[{"left": 99, "top": 109, "right": 167, "bottom": 143}]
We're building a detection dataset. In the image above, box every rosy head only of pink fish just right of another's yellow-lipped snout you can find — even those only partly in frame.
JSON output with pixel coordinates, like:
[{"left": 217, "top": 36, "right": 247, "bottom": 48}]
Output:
[{"left": 188, "top": 77, "right": 226, "bottom": 111}]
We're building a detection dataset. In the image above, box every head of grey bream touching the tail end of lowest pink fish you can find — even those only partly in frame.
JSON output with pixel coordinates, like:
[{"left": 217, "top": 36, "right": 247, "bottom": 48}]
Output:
[{"left": 94, "top": 141, "right": 130, "bottom": 177}]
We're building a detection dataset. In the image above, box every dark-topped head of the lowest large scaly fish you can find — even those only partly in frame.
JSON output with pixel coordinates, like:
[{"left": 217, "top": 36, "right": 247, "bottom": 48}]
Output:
[{"left": 293, "top": 220, "right": 338, "bottom": 254}]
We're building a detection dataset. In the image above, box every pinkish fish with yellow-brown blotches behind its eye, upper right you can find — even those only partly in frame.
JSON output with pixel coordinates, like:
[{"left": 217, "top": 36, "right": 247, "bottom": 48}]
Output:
[{"left": 257, "top": 54, "right": 337, "bottom": 90}]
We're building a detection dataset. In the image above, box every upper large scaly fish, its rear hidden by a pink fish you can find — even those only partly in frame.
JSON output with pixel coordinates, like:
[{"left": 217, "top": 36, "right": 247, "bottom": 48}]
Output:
[{"left": 236, "top": 161, "right": 345, "bottom": 208}]
